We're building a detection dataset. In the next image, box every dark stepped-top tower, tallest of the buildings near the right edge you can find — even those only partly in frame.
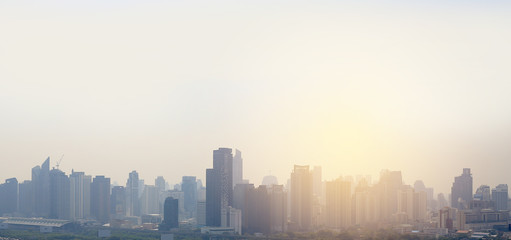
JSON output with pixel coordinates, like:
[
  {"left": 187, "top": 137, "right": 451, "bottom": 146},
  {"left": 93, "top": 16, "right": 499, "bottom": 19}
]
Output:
[{"left": 451, "top": 168, "right": 473, "bottom": 210}]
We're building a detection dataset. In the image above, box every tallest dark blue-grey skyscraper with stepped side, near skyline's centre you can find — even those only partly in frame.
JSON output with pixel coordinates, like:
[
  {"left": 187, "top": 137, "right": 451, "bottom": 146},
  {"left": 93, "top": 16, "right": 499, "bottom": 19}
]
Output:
[{"left": 206, "top": 148, "right": 233, "bottom": 226}]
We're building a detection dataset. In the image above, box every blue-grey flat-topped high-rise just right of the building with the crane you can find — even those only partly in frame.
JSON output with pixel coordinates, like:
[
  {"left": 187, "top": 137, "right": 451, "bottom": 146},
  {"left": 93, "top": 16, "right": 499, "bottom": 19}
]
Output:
[{"left": 69, "top": 171, "right": 91, "bottom": 220}]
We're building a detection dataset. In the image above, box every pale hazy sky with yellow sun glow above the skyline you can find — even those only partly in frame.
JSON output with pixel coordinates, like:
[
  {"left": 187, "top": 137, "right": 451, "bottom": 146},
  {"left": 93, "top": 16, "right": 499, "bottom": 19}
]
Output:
[{"left": 0, "top": 0, "right": 511, "bottom": 193}]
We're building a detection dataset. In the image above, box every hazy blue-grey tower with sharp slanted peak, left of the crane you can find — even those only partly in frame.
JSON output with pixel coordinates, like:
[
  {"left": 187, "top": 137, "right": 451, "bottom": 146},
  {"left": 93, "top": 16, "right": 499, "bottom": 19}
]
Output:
[{"left": 32, "top": 157, "right": 50, "bottom": 217}]
